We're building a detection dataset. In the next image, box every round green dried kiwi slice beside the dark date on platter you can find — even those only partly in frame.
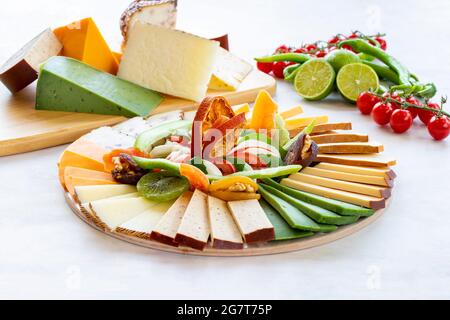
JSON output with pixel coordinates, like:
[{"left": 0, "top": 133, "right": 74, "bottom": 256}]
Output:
[{"left": 137, "top": 171, "right": 190, "bottom": 202}]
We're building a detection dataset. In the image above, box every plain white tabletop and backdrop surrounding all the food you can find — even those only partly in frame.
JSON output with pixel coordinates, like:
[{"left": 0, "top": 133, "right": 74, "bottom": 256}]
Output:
[{"left": 0, "top": 0, "right": 450, "bottom": 299}]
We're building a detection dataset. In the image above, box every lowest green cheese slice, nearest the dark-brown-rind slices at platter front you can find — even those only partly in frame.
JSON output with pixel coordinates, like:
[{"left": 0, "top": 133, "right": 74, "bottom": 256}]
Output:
[{"left": 259, "top": 200, "right": 314, "bottom": 241}]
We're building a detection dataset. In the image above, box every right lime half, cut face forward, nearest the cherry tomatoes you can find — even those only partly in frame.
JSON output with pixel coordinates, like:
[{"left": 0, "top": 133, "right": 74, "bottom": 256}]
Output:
[{"left": 336, "top": 63, "right": 380, "bottom": 102}]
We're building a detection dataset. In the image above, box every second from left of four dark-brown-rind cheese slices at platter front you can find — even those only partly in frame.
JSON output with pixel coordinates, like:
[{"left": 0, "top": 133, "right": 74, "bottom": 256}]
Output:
[{"left": 175, "top": 189, "right": 211, "bottom": 250}]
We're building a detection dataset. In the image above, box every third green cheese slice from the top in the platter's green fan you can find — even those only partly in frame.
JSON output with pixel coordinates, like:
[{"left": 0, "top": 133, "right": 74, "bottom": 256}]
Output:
[{"left": 259, "top": 186, "right": 320, "bottom": 231}]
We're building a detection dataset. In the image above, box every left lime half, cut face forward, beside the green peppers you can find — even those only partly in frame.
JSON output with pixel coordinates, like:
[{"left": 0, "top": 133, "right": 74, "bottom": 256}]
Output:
[{"left": 294, "top": 59, "right": 336, "bottom": 100}]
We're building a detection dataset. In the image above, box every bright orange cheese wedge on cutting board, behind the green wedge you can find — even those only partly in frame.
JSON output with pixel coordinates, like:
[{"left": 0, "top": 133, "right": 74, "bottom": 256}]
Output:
[{"left": 53, "top": 18, "right": 119, "bottom": 75}]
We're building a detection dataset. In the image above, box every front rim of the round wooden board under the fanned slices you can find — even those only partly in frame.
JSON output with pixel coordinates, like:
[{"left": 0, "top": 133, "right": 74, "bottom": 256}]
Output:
[{"left": 65, "top": 193, "right": 384, "bottom": 257}]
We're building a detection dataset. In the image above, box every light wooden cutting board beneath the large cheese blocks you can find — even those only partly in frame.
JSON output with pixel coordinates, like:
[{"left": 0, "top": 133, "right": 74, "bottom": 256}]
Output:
[{"left": 0, "top": 69, "right": 276, "bottom": 156}]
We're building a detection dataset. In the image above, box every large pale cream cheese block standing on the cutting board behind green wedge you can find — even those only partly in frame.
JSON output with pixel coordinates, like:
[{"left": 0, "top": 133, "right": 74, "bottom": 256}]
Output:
[{"left": 118, "top": 22, "right": 219, "bottom": 102}]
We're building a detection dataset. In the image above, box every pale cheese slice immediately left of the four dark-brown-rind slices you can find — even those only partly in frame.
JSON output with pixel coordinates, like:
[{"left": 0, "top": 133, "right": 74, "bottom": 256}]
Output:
[{"left": 116, "top": 202, "right": 173, "bottom": 239}]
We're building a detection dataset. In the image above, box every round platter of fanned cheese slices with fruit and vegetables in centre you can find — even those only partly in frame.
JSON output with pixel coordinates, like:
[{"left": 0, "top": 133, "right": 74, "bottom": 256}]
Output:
[{"left": 58, "top": 90, "right": 396, "bottom": 256}]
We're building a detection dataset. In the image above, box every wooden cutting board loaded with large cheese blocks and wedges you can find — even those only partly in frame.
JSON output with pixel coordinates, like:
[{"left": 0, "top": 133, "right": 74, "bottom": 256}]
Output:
[{"left": 0, "top": 1, "right": 276, "bottom": 156}]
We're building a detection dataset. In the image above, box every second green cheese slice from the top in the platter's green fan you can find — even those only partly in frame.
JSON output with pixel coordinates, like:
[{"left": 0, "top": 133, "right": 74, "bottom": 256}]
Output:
[{"left": 264, "top": 185, "right": 359, "bottom": 226}]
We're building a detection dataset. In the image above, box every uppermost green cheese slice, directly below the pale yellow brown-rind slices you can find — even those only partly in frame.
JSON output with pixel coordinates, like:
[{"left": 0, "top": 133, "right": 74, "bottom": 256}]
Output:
[{"left": 263, "top": 179, "right": 374, "bottom": 217}]
